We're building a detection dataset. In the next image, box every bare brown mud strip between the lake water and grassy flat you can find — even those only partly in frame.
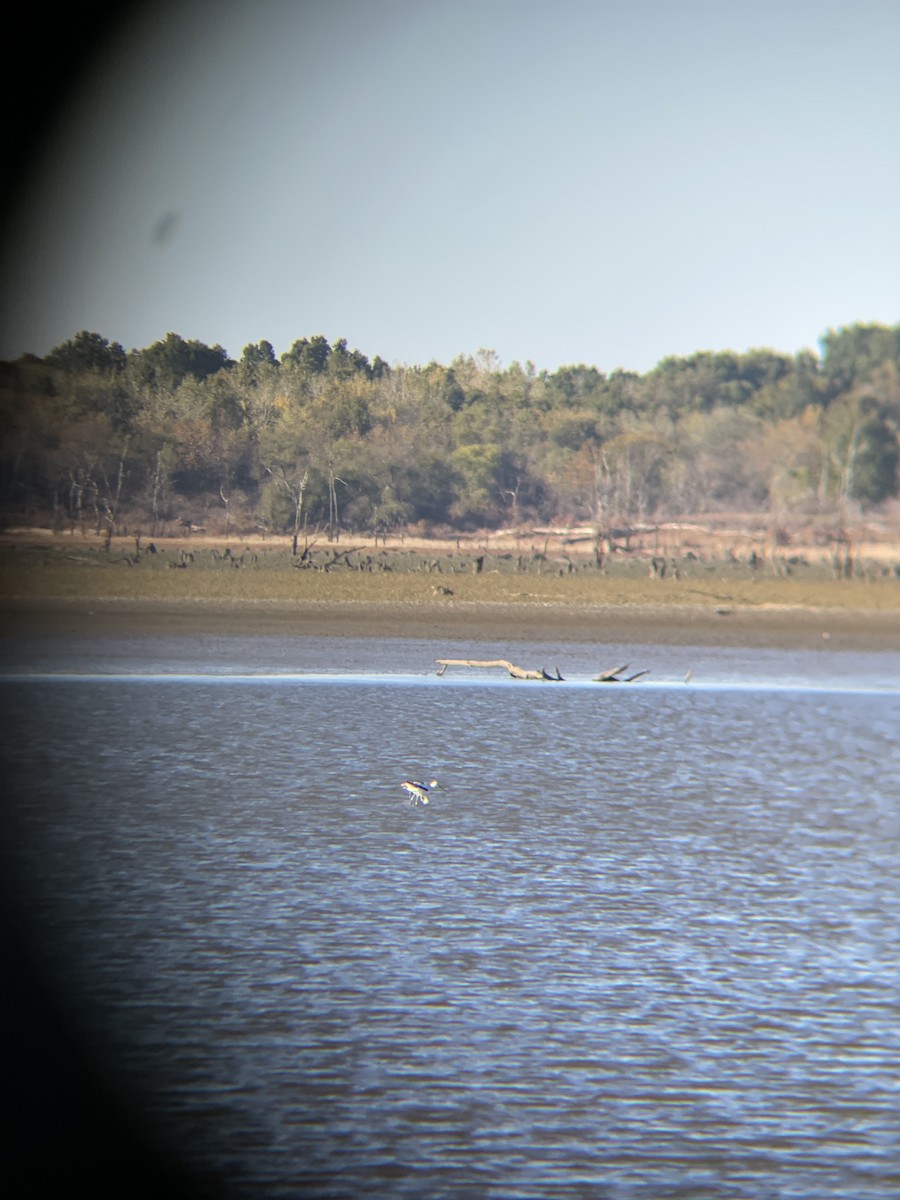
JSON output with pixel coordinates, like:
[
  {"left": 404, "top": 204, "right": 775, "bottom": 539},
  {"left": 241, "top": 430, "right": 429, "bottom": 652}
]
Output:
[{"left": 0, "top": 598, "right": 900, "bottom": 652}]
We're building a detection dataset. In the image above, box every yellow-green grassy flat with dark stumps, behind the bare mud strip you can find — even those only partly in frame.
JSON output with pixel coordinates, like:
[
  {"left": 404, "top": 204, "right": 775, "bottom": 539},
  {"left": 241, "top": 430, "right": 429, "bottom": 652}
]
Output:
[{"left": 0, "top": 542, "right": 900, "bottom": 612}]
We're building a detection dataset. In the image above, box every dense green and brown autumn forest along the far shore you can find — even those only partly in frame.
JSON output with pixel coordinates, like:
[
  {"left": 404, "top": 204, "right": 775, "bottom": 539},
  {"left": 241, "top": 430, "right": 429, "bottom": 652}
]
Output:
[{"left": 0, "top": 325, "right": 900, "bottom": 538}]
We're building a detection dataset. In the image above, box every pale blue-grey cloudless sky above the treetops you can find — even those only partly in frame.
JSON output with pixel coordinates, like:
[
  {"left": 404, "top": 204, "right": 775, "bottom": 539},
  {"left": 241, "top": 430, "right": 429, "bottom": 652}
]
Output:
[{"left": 0, "top": 0, "right": 900, "bottom": 373}]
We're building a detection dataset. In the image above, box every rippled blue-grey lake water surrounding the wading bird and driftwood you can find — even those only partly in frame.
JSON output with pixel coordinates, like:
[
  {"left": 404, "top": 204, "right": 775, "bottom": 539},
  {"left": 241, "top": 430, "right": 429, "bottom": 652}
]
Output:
[{"left": 0, "top": 637, "right": 900, "bottom": 1200}]
